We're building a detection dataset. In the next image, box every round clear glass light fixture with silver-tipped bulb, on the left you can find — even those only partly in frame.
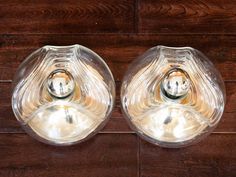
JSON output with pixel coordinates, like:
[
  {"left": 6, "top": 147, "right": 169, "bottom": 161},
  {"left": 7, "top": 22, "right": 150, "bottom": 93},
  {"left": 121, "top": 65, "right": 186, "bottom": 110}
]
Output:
[{"left": 12, "top": 45, "right": 115, "bottom": 145}]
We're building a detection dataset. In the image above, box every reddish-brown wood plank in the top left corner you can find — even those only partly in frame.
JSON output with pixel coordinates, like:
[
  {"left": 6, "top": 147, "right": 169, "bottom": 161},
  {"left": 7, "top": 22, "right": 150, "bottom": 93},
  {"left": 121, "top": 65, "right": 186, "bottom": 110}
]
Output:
[{"left": 0, "top": 0, "right": 134, "bottom": 34}]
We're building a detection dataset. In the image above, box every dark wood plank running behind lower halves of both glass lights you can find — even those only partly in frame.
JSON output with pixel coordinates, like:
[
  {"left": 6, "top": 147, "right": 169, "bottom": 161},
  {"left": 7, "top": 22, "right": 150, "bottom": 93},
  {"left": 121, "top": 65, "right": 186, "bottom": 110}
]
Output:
[{"left": 0, "top": 82, "right": 236, "bottom": 133}]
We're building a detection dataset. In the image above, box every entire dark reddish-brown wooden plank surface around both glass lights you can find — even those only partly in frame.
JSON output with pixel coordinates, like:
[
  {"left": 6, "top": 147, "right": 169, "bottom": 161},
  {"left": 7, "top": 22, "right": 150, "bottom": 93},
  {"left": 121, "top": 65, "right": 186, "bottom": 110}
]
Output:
[{"left": 0, "top": 0, "right": 236, "bottom": 177}]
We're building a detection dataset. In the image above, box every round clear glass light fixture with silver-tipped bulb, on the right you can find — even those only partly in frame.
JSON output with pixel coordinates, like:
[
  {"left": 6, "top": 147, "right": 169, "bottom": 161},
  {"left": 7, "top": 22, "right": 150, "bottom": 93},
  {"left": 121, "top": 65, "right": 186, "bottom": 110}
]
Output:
[{"left": 121, "top": 46, "right": 225, "bottom": 148}]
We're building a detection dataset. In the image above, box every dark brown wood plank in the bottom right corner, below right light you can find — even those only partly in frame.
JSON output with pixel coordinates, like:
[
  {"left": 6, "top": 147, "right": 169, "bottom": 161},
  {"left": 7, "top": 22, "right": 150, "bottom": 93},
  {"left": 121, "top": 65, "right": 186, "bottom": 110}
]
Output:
[{"left": 140, "top": 134, "right": 236, "bottom": 177}]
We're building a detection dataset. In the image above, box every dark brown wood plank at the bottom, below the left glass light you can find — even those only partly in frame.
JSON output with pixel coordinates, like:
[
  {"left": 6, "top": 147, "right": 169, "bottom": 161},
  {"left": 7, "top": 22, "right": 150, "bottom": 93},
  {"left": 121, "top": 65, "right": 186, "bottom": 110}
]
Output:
[{"left": 0, "top": 134, "right": 138, "bottom": 177}]
